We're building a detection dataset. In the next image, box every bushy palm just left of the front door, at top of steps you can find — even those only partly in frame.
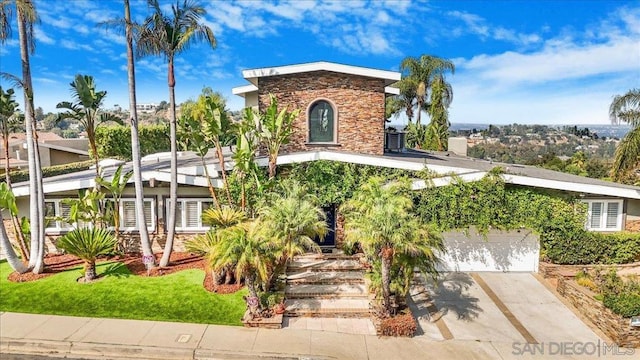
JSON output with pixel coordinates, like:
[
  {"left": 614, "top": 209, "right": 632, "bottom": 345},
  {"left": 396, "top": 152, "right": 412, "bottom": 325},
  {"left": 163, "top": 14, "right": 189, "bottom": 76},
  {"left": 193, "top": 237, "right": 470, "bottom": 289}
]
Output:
[{"left": 259, "top": 181, "right": 327, "bottom": 264}]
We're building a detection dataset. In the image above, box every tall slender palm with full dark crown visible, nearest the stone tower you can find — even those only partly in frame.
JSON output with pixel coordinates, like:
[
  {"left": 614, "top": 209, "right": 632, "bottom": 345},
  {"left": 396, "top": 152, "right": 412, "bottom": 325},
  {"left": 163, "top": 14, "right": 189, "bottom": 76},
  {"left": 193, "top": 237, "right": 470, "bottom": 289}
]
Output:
[{"left": 136, "top": 0, "right": 216, "bottom": 266}]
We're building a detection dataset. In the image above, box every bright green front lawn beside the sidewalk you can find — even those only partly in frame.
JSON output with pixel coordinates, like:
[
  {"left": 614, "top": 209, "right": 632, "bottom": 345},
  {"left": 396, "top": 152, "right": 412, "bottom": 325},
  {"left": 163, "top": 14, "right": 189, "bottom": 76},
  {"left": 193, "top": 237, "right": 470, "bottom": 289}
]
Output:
[{"left": 0, "top": 261, "right": 246, "bottom": 325}]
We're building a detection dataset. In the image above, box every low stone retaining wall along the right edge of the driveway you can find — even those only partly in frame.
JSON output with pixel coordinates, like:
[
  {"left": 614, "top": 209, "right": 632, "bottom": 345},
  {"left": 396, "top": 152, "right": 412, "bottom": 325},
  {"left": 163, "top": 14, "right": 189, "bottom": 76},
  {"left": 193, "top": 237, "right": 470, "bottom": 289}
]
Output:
[{"left": 557, "top": 277, "right": 640, "bottom": 348}]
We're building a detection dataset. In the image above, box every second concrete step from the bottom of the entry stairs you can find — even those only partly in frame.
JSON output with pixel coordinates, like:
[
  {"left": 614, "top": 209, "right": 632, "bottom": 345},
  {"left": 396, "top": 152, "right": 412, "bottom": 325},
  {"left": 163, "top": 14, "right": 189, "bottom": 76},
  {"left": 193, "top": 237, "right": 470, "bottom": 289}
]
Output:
[{"left": 285, "top": 284, "right": 368, "bottom": 299}]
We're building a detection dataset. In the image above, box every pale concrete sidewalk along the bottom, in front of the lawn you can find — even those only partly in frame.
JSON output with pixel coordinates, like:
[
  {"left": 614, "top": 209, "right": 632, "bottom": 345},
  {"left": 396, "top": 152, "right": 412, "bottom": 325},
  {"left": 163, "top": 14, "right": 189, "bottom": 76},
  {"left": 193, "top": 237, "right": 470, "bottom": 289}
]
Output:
[{"left": 0, "top": 313, "right": 512, "bottom": 360}]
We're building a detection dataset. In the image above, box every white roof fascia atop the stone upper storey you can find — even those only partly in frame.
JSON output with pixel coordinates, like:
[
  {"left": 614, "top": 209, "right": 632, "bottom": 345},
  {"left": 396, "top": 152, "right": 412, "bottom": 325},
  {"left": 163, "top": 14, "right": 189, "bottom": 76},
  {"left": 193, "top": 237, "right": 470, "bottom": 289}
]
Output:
[{"left": 242, "top": 61, "right": 402, "bottom": 85}]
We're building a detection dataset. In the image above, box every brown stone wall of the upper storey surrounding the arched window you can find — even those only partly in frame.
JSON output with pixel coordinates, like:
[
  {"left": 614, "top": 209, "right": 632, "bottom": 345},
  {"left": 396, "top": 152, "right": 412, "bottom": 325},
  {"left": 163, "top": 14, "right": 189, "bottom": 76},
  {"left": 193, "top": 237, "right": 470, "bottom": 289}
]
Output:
[{"left": 258, "top": 71, "right": 385, "bottom": 155}]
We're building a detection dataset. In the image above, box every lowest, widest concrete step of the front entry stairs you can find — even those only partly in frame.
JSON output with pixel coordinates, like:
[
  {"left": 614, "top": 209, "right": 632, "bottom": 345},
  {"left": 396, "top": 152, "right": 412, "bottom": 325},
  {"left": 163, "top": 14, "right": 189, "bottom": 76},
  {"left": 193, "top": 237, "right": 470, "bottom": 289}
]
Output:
[{"left": 284, "top": 299, "right": 370, "bottom": 317}]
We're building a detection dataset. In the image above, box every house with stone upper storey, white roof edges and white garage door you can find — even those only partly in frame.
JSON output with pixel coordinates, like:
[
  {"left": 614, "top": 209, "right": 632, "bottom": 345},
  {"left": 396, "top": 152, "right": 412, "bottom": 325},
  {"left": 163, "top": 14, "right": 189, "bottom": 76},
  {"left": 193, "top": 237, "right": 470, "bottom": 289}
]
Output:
[{"left": 5, "top": 62, "right": 640, "bottom": 271}]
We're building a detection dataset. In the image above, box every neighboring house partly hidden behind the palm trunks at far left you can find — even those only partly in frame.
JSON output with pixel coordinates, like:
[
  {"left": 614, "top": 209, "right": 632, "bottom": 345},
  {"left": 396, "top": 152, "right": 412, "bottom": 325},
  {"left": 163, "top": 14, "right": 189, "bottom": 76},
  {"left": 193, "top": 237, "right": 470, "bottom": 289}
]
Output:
[{"left": 0, "top": 132, "right": 89, "bottom": 173}]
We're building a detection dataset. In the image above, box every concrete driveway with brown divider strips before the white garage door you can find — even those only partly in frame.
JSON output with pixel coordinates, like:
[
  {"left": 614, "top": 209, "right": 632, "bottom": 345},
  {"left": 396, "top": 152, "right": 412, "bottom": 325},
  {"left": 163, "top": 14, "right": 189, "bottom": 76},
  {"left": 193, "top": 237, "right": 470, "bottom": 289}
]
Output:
[{"left": 412, "top": 272, "right": 605, "bottom": 355}]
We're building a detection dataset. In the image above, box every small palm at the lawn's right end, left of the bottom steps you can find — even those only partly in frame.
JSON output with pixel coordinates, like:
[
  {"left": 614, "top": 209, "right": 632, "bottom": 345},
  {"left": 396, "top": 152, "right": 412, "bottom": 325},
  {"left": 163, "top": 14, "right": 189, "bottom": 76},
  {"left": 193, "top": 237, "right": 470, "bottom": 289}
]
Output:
[{"left": 207, "top": 220, "right": 273, "bottom": 314}]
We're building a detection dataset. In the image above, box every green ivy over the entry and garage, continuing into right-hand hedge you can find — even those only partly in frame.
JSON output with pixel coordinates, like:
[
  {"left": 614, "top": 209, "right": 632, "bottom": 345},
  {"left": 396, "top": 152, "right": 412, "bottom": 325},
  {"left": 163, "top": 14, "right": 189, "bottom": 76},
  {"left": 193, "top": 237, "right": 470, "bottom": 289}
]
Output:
[{"left": 279, "top": 161, "right": 640, "bottom": 264}]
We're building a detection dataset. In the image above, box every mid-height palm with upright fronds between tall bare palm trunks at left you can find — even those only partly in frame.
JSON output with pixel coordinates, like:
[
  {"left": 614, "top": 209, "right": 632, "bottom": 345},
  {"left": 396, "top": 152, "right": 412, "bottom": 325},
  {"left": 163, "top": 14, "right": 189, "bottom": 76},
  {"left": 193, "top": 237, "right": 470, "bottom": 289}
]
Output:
[{"left": 56, "top": 74, "right": 122, "bottom": 178}]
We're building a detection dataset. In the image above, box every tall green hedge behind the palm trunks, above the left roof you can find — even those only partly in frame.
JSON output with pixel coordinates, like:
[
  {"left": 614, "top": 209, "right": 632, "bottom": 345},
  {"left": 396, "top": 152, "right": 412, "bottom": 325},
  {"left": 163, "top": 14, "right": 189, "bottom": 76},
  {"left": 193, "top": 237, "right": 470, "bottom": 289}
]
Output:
[{"left": 96, "top": 125, "right": 171, "bottom": 160}]
